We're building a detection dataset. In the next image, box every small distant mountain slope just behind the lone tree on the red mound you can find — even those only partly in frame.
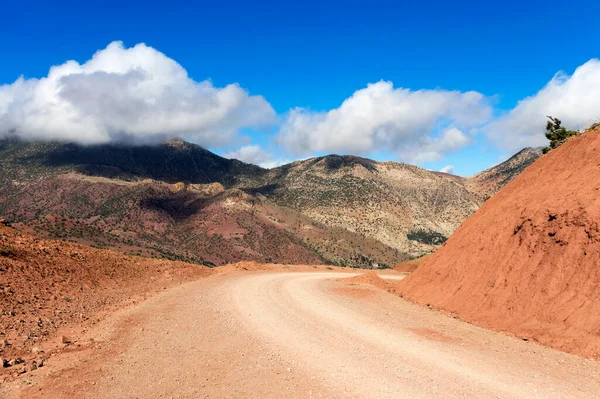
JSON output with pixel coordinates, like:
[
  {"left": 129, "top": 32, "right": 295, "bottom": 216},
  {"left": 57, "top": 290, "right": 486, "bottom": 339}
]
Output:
[{"left": 464, "top": 148, "right": 542, "bottom": 200}]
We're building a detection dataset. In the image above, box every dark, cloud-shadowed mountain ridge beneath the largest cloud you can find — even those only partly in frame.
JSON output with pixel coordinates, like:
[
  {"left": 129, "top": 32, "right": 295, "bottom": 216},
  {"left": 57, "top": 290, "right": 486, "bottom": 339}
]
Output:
[{"left": 0, "top": 139, "right": 264, "bottom": 191}]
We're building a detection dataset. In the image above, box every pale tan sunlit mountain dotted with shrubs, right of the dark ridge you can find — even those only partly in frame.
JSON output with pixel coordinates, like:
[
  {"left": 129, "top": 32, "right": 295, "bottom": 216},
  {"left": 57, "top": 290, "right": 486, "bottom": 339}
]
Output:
[{"left": 256, "top": 155, "right": 479, "bottom": 256}]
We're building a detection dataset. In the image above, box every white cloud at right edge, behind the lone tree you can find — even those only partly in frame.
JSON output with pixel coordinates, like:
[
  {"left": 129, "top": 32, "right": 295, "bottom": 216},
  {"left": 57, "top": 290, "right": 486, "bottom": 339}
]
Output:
[{"left": 486, "top": 59, "right": 600, "bottom": 151}]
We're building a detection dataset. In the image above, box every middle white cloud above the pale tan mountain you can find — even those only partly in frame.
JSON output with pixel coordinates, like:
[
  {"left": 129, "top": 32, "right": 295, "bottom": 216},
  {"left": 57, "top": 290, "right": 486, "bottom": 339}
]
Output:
[{"left": 279, "top": 81, "right": 491, "bottom": 162}]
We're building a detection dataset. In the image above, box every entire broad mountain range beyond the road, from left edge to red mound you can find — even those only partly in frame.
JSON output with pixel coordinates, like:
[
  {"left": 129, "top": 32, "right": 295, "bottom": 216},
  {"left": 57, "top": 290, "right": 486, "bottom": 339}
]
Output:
[{"left": 0, "top": 139, "right": 532, "bottom": 267}]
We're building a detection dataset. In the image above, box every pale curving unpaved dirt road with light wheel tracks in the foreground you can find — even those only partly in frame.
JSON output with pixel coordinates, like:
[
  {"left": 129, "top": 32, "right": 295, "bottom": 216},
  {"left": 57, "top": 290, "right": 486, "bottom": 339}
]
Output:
[{"left": 0, "top": 272, "right": 600, "bottom": 398}]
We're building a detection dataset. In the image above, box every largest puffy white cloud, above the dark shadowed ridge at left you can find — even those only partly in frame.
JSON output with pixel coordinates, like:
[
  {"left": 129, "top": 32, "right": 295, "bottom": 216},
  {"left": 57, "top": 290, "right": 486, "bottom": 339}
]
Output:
[{"left": 0, "top": 42, "right": 275, "bottom": 146}]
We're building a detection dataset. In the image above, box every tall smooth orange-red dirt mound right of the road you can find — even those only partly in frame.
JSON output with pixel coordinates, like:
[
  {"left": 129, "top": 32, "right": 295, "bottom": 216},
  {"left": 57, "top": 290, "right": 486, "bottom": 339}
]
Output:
[{"left": 398, "top": 129, "right": 600, "bottom": 358}]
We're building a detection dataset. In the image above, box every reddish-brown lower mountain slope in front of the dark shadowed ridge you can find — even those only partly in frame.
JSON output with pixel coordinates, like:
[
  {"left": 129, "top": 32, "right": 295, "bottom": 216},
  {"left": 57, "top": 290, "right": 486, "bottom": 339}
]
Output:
[{"left": 0, "top": 173, "right": 330, "bottom": 266}]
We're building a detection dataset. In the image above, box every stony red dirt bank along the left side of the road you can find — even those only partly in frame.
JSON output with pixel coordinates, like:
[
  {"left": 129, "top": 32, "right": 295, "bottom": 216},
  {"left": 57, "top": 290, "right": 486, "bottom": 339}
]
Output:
[{"left": 0, "top": 224, "right": 212, "bottom": 362}]
